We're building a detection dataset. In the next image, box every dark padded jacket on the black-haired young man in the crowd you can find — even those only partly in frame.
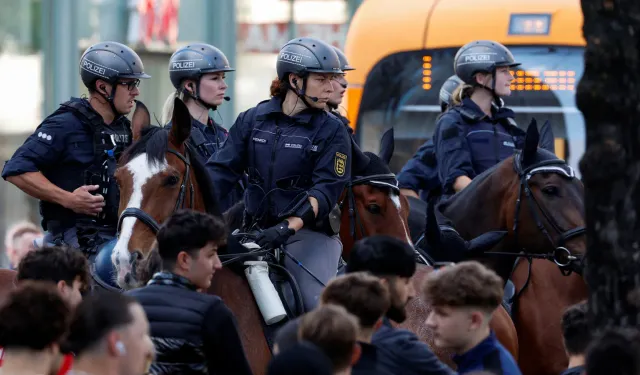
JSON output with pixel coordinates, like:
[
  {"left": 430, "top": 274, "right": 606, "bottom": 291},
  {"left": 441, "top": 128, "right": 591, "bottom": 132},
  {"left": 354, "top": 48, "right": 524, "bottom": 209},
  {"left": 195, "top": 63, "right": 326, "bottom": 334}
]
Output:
[{"left": 126, "top": 272, "right": 252, "bottom": 375}]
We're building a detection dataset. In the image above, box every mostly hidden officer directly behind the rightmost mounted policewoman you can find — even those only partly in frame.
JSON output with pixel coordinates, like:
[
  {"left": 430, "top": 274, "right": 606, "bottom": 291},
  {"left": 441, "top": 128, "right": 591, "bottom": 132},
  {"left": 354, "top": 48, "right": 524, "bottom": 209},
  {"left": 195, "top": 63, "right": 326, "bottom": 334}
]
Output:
[{"left": 398, "top": 74, "right": 462, "bottom": 202}]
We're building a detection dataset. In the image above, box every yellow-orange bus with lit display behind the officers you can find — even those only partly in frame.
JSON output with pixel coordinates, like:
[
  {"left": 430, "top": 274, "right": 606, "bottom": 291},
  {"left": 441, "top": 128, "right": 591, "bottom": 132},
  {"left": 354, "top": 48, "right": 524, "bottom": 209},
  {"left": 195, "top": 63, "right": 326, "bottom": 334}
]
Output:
[{"left": 345, "top": 0, "right": 585, "bottom": 176}]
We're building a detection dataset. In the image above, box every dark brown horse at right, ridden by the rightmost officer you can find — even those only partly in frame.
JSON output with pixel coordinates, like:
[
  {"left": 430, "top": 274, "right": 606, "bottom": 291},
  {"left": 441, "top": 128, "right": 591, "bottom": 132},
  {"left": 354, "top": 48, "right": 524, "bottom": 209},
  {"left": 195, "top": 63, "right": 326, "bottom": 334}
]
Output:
[{"left": 408, "top": 123, "right": 587, "bottom": 375}]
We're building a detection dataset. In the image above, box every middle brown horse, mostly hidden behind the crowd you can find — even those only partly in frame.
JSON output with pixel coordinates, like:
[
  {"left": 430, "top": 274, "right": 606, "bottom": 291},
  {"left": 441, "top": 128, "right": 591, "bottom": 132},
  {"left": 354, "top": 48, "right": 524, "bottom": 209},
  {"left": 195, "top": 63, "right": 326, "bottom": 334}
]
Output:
[{"left": 340, "top": 152, "right": 519, "bottom": 368}]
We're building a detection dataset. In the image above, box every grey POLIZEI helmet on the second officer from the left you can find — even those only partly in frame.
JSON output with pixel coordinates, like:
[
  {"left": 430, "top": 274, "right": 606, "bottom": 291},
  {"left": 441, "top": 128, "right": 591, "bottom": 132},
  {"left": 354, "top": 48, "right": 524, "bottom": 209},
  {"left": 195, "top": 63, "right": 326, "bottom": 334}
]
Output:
[{"left": 169, "top": 43, "right": 235, "bottom": 89}]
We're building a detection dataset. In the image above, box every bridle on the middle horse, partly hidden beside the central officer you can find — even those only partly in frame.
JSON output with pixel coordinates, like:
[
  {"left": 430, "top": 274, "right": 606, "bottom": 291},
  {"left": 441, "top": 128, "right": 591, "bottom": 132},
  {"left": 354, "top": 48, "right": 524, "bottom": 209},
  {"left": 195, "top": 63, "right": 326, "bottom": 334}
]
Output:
[{"left": 338, "top": 173, "right": 430, "bottom": 265}]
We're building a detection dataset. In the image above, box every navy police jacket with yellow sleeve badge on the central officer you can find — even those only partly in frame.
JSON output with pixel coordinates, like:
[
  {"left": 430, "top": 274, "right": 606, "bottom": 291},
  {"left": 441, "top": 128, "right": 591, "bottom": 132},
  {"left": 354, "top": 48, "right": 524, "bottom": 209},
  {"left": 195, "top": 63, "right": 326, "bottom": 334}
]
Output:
[{"left": 207, "top": 98, "right": 351, "bottom": 226}]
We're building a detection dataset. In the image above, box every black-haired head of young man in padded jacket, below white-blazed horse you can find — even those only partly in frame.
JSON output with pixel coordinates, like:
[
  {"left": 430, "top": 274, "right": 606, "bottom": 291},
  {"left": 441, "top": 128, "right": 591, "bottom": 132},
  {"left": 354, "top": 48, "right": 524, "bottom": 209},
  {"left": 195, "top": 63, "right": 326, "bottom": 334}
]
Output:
[{"left": 157, "top": 210, "right": 227, "bottom": 290}]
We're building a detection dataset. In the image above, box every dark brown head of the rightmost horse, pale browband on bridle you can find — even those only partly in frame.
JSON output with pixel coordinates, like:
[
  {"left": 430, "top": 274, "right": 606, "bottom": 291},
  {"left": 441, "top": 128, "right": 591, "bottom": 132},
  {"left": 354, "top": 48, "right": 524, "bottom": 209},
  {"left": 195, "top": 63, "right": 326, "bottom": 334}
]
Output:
[{"left": 440, "top": 121, "right": 586, "bottom": 276}]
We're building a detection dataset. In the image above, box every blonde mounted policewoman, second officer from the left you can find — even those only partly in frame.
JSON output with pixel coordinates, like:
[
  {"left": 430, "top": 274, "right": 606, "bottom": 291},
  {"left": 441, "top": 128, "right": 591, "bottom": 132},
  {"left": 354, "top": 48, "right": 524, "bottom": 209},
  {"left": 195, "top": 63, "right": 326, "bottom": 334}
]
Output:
[{"left": 163, "top": 43, "right": 246, "bottom": 212}]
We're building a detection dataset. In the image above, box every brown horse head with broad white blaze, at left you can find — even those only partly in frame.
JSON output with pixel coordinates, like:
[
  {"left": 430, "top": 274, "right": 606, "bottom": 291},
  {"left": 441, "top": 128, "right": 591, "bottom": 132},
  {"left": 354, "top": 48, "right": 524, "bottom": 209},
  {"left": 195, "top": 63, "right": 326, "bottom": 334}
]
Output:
[{"left": 111, "top": 98, "right": 204, "bottom": 289}]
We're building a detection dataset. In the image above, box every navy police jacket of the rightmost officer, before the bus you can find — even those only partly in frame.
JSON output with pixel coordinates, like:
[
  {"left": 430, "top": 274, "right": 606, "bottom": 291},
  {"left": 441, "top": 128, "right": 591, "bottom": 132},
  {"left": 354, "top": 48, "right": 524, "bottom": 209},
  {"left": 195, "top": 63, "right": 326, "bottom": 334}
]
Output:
[{"left": 434, "top": 98, "right": 525, "bottom": 193}]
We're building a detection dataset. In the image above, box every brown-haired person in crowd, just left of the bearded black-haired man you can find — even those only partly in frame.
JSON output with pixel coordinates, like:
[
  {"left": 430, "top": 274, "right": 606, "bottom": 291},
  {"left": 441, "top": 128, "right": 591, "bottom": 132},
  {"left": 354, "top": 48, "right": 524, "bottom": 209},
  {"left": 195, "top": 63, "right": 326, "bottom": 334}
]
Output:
[{"left": 320, "top": 272, "right": 393, "bottom": 375}]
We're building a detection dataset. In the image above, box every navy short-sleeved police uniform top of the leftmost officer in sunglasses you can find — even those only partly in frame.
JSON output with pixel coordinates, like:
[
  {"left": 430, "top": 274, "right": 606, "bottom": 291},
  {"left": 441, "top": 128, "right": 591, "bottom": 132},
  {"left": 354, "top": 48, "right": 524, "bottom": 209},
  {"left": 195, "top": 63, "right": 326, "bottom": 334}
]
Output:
[{"left": 2, "top": 98, "right": 132, "bottom": 230}]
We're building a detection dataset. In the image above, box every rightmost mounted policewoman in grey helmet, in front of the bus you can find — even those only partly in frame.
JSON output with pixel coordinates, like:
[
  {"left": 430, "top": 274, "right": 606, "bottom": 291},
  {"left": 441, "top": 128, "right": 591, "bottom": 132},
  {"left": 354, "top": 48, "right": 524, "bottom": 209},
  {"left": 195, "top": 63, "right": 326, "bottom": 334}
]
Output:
[{"left": 434, "top": 40, "right": 524, "bottom": 195}]
